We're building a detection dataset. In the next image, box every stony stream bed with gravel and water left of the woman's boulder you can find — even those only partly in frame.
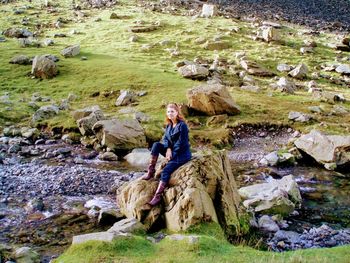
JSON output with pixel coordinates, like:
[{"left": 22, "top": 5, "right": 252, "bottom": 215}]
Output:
[{"left": 0, "top": 137, "right": 141, "bottom": 262}]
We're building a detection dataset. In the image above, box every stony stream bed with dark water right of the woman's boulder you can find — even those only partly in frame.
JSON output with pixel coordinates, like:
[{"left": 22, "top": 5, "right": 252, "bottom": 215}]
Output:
[{"left": 228, "top": 125, "right": 350, "bottom": 251}]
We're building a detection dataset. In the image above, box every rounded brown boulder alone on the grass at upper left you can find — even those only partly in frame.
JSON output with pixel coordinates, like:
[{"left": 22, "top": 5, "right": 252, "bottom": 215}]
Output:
[{"left": 32, "top": 56, "right": 58, "bottom": 79}]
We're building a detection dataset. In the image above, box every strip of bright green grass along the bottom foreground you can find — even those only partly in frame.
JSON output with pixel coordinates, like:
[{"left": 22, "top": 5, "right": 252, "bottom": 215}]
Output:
[{"left": 55, "top": 235, "right": 350, "bottom": 263}]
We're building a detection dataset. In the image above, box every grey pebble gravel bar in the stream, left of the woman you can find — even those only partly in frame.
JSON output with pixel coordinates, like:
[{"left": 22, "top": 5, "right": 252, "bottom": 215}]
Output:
[{"left": 0, "top": 163, "right": 122, "bottom": 197}]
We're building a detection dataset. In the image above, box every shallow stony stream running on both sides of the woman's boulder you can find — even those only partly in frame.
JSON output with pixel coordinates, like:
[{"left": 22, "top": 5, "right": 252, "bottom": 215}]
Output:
[{"left": 0, "top": 127, "right": 350, "bottom": 262}]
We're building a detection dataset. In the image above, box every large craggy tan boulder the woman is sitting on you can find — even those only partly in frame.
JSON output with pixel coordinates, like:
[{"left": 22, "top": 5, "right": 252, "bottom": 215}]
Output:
[{"left": 117, "top": 152, "right": 247, "bottom": 235}]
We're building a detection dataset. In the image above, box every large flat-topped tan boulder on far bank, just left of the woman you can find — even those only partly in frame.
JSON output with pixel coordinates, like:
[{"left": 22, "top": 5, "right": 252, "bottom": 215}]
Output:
[{"left": 93, "top": 119, "right": 146, "bottom": 151}]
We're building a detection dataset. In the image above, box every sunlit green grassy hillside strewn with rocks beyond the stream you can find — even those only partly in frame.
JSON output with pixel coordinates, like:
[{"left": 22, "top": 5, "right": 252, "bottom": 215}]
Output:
[{"left": 0, "top": 1, "right": 350, "bottom": 144}]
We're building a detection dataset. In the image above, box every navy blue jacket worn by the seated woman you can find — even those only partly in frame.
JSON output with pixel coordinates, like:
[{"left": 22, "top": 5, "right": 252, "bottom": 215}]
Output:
[{"left": 163, "top": 121, "right": 192, "bottom": 162}]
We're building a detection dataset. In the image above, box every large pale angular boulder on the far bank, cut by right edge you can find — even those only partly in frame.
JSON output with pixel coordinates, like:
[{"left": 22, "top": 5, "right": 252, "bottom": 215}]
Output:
[{"left": 294, "top": 130, "right": 350, "bottom": 167}]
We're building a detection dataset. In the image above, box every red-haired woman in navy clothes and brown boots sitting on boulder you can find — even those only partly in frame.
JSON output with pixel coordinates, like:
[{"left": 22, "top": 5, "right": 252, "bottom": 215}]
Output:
[{"left": 142, "top": 103, "right": 191, "bottom": 206}]
